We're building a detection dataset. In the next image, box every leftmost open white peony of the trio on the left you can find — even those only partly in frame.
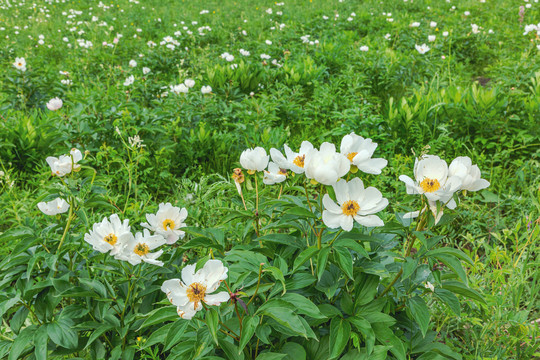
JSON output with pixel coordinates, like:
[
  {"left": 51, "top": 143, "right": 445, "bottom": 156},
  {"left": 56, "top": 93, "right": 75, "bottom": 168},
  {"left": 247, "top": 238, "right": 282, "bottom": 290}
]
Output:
[{"left": 84, "top": 214, "right": 133, "bottom": 255}]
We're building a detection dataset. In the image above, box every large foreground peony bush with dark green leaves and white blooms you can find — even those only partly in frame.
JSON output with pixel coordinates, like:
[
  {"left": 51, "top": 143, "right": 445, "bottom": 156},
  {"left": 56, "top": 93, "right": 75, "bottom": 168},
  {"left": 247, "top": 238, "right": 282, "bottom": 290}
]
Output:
[{"left": 0, "top": 133, "right": 489, "bottom": 360}]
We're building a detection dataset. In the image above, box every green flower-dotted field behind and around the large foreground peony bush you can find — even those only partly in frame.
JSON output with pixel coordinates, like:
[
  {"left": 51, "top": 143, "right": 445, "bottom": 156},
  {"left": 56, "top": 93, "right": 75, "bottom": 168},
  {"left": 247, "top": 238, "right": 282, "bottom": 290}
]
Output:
[{"left": 0, "top": 0, "right": 540, "bottom": 359}]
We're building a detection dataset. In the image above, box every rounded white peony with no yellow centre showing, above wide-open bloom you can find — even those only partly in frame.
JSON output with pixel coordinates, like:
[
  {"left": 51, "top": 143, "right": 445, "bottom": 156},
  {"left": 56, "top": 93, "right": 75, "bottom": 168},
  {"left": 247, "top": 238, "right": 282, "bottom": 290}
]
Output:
[{"left": 305, "top": 142, "right": 351, "bottom": 185}]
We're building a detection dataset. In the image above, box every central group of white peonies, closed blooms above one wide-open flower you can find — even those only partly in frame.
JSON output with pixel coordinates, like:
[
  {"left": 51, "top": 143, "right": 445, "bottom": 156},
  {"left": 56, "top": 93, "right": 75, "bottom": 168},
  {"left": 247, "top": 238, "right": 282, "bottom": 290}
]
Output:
[{"left": 240, "top": 132, "right": 388, "bottom": 231}]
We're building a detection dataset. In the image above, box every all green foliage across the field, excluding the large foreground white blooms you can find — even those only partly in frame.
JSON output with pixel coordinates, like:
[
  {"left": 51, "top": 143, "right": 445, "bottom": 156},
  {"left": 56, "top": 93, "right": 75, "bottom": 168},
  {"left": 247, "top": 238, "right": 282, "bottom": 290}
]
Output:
[{"left": 0, "top": 0, "right": 540, "bottom": 360}]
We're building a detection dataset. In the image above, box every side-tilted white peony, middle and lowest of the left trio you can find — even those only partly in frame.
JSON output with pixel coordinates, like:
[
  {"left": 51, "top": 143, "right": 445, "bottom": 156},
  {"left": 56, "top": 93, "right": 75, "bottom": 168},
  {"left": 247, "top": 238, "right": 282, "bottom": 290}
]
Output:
[{"left": 116, "top": 229, "right": 167, "bottom": 266}]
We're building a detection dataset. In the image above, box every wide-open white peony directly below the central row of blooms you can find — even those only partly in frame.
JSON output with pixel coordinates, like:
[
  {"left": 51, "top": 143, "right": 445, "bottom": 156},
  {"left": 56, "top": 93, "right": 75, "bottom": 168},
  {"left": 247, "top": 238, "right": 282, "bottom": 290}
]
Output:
[{"left": 322, "top": 178, "right": 388, "bottom": 231}]
